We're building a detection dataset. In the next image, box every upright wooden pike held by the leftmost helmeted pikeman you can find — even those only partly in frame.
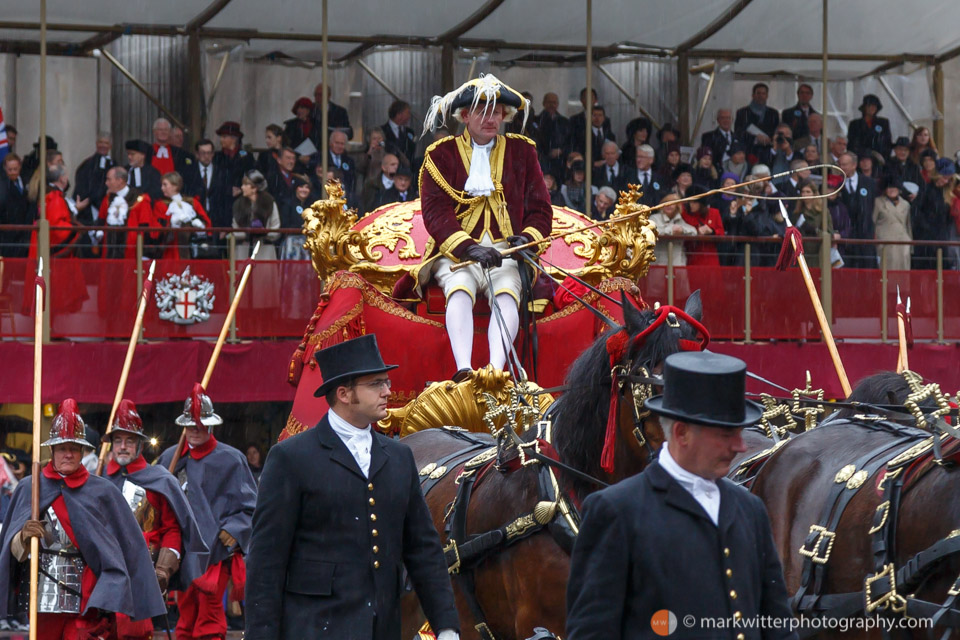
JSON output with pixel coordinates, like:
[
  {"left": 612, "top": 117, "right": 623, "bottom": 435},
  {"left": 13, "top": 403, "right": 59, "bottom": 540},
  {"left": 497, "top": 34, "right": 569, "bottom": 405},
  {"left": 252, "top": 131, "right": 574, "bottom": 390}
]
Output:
[{"left": 29, "top": 258, "right": 46, "bottom": 640}]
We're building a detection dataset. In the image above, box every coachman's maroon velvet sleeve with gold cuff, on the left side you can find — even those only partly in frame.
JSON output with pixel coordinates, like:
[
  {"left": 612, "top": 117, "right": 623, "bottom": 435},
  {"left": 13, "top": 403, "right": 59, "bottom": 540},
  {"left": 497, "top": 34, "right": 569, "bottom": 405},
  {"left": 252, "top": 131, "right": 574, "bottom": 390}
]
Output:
[{"left": 420, "top": 138, "right": 476, "bottom": 261}]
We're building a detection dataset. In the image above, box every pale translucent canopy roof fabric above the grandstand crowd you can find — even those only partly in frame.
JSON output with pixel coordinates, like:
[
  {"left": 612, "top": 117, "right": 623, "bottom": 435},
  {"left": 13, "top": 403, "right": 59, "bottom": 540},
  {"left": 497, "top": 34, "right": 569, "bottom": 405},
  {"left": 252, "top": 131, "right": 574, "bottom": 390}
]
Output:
[{"left": 0, "top": 0, "right": 960, "bottom": 74}]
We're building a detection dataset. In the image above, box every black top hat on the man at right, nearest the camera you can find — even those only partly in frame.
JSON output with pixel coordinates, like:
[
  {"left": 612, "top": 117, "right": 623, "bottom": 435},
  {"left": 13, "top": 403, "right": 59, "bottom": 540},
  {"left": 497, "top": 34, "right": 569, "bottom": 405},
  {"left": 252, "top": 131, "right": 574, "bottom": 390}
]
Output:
[{"left": 644, "top": 351, "right": 763, "bottom": 429}]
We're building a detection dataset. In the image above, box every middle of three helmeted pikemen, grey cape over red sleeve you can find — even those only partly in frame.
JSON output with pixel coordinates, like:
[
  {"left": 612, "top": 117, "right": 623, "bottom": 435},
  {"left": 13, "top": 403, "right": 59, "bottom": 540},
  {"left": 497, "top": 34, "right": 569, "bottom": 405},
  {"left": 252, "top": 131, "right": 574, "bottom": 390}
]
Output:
[{"left": 107, "top": 399, "right": 207, "bottom": 640}]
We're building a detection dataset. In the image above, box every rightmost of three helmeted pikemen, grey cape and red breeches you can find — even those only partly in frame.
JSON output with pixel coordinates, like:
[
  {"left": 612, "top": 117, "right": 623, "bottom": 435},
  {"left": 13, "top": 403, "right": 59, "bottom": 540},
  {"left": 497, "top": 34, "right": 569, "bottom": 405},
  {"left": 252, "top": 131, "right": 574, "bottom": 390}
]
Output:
[{"left": 157, "top": 384, "right": 257, "bottom": 640}]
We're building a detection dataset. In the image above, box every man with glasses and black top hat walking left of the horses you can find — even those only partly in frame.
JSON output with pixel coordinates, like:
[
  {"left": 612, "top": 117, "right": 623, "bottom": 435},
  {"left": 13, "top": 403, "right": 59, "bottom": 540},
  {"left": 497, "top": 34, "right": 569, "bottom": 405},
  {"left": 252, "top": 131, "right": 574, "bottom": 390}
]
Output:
[{"left": 245, "top": 335, "right": 460, "bottom": 640}]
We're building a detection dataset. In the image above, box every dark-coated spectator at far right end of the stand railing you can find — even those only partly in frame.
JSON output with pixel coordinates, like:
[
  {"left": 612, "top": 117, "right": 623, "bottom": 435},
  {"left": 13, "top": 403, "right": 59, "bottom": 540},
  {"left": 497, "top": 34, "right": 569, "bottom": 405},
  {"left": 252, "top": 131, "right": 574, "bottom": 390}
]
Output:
[{"left": 912, "top": 158, "right": 957, "bottom": 269}]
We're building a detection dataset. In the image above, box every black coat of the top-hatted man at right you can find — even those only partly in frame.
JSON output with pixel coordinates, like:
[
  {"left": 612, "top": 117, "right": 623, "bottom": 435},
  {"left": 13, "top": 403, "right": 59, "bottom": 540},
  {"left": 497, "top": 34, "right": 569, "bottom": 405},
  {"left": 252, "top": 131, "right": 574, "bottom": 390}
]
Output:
[{"left": 564, "top": 463, "right": 796, "bottom": 640}]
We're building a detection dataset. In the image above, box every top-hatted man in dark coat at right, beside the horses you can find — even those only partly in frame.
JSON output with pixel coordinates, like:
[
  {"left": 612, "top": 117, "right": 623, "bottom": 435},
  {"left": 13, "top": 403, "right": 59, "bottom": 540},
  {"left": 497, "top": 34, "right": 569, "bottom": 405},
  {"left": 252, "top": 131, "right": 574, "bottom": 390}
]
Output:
[{"left": 565, "top": 352, "right": 797, "bottom": 640}]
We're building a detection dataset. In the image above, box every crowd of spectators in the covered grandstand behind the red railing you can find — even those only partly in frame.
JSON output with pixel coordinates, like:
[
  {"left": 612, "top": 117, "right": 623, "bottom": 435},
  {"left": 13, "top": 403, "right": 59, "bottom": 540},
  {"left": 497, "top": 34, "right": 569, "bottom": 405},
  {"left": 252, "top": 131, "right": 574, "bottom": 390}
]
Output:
[{"left": 0, "top": 83, "right": 960, "bottom": 270}]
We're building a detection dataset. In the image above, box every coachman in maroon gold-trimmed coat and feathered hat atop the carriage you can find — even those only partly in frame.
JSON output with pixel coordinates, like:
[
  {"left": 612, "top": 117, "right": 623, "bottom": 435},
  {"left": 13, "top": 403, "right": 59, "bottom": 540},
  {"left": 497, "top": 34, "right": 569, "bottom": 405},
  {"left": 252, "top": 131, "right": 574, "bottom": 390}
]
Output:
[{"left": 395, "top": 75, "right": 553, "bottom": 380}]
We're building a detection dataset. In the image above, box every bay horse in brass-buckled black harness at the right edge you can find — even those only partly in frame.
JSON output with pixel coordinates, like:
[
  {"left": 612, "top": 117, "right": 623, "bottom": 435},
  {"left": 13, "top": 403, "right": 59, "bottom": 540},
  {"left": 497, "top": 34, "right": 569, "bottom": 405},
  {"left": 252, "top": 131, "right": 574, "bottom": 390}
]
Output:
[{"left": 752, "top": 373, "right": 960, "bottom": 637}]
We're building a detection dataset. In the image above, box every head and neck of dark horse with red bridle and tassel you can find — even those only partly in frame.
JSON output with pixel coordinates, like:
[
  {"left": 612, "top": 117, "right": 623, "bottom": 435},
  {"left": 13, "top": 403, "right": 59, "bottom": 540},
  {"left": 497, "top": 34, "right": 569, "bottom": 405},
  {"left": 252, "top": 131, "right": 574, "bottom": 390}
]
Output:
[{"left": 551, "top": 291, "right": 709, "bottom": 496}]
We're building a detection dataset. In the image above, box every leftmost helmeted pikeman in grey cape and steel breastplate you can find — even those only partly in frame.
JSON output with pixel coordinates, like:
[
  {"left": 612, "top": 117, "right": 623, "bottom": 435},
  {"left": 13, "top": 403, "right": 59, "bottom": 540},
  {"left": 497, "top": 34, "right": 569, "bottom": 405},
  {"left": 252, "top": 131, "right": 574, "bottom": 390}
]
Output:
[{"left": 0, "top": 398, "right": 166, "bottom": 640}]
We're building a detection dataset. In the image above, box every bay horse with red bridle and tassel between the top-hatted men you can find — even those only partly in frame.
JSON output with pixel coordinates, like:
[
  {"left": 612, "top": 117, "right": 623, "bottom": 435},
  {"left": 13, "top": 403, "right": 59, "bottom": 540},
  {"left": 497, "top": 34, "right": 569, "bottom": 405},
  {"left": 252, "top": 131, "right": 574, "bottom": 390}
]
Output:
[{"left": 402, "top": 294, "right": 764, "bottom": 640}]
